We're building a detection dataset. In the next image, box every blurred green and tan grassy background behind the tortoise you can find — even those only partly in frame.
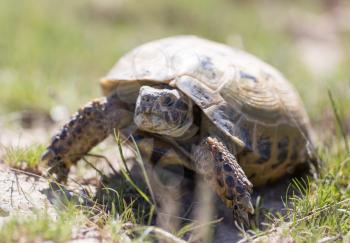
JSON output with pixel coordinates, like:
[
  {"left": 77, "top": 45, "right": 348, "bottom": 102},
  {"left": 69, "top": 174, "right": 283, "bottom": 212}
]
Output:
[{"left": 0, "top": 0, "right": 350, "bottom": 123}]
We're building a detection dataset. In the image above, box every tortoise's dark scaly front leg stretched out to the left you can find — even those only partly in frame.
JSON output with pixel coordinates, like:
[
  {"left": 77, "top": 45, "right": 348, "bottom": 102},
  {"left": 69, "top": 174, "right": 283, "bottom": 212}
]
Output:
[{"left": 42, "top": 94, "right": 133, "bottom": 181}]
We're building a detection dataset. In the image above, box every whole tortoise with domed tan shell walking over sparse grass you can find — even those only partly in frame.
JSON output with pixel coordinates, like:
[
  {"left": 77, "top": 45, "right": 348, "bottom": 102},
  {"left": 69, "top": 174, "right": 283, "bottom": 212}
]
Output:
[{"left": 42, "top": 36, "right": 315, "bottom": 226}]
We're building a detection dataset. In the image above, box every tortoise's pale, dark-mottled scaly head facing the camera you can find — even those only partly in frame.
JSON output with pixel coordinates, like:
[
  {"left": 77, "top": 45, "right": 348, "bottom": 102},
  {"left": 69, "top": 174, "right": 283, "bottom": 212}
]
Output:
[{"left": 134, "top": 86, "right": 193, "bottom": 137}]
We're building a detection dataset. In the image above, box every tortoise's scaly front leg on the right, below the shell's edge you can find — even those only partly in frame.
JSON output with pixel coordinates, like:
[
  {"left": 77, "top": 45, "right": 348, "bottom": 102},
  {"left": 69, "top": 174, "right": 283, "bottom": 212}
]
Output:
[{"left": 194, "top": 137, "right": 254, "bottom": 225}]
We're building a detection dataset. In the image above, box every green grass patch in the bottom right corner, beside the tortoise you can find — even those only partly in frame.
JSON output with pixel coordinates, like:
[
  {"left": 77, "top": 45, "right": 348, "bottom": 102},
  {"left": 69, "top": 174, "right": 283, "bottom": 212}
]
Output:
[{"left": 246, "top": 147, "right": 350, "bottom": 242}]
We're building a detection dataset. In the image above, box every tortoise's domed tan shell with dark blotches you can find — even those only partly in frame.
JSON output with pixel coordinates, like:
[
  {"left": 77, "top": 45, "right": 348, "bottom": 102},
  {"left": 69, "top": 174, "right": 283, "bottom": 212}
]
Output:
[{"left": 101, "top": 36, "right": 313, "bottom": 186}]
